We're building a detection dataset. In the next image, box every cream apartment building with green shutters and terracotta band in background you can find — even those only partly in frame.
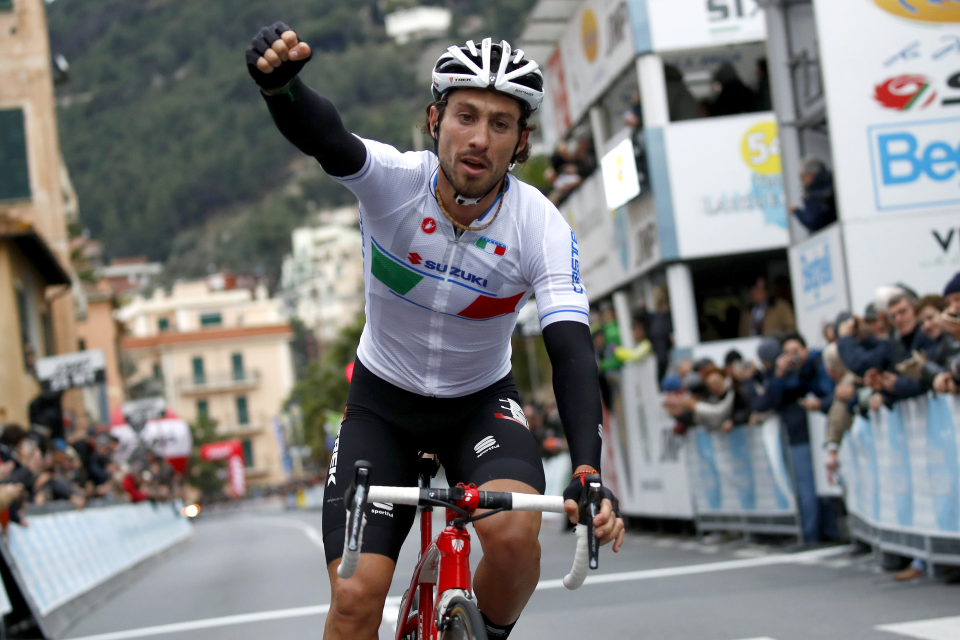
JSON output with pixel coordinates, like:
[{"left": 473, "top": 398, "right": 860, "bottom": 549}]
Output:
[{"left": 116, "top": 274, "right": 294, "bottom": 485}]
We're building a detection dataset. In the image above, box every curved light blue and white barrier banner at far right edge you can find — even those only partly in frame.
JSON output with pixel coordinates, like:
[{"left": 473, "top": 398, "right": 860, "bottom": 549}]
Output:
[{"left": 840, "top": 396, "right": 960, "bottom": 540}]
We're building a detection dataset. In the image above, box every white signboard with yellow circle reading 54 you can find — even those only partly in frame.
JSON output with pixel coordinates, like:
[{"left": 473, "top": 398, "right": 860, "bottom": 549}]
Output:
[{"left": 664, "top": 112, "right": 788, "bottom": 258}]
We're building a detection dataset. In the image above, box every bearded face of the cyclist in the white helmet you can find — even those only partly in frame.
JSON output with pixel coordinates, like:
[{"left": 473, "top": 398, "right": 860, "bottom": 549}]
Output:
[{"left": 430, "top": 89, "right": 529, "bottom": 198}]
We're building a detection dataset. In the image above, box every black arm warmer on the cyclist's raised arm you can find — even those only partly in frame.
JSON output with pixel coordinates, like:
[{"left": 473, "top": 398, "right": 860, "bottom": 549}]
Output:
[{"left": 263, "top": 78, "right": 367, "bottom": 178}]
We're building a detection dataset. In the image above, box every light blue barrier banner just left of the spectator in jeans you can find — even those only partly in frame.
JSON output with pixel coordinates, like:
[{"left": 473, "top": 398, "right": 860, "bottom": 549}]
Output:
[{"left": 687, "top": 418, "right": 797, "bottom": 518}]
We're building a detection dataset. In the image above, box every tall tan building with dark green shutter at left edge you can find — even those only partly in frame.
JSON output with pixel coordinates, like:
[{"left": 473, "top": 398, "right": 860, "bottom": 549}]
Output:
[{"left": 0, "top": 0, "right": 83, "bottom": 422}]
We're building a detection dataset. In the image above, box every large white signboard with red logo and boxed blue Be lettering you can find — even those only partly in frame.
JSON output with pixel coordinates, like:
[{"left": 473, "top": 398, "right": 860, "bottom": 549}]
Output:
[{"left": 814, "top": 0, "right": 960, "bottom": 225}]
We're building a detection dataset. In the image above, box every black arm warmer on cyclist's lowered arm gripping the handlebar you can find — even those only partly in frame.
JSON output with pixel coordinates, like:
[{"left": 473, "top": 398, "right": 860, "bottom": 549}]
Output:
[{"left": 543, "top": 321, "right": 603, "bottom": 471}]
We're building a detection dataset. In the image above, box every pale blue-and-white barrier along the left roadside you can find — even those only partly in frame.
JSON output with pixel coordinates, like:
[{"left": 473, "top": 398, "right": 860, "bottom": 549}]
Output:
[{"left": 0, "top": 502, "right": 192, "bottom": 638}]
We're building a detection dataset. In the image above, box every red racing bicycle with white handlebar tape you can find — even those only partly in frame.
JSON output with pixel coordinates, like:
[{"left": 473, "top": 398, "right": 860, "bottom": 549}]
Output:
[{"left": 337, "top": 458, "right": 603, "bottom": 640}]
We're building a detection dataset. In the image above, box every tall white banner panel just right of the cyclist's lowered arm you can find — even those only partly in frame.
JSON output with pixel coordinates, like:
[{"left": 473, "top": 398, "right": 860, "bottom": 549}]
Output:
[{"left": 604, "top": 358, "right": 693, "bottom": 519}]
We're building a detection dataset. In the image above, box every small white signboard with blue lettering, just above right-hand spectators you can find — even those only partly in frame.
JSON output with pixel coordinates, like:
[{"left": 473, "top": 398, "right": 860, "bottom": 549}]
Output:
[{"left": 789, "top": 224, "right": 848, "bottom": 347}]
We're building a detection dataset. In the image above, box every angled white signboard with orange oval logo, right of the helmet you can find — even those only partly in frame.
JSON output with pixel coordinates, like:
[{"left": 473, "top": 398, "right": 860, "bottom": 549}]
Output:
[{"left": 548, "top": 0, "right": 635, "bottom": 128}]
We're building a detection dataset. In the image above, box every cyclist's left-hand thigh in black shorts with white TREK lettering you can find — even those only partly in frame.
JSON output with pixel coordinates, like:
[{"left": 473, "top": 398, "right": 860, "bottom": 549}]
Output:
[{"left": 323, "top": 405, "right": 417, "bottom": 565}]
